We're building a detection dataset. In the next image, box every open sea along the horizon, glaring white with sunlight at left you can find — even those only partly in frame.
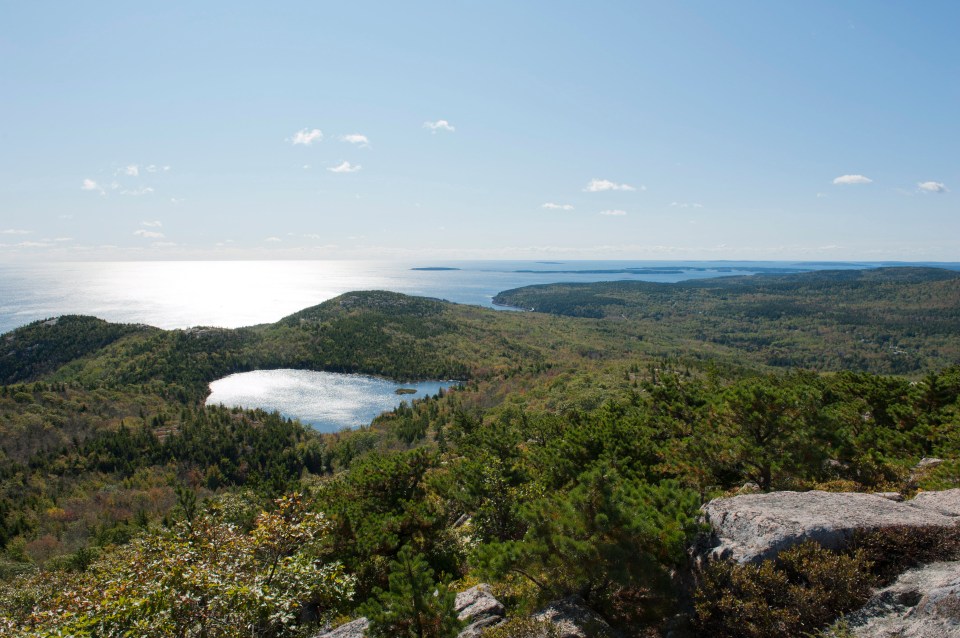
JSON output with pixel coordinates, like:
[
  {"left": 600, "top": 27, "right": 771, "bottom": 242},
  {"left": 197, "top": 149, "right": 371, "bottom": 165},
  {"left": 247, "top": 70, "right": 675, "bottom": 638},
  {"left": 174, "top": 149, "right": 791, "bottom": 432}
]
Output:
[{"left": 0, "top": 261, "right": 960, "bottom": 333}]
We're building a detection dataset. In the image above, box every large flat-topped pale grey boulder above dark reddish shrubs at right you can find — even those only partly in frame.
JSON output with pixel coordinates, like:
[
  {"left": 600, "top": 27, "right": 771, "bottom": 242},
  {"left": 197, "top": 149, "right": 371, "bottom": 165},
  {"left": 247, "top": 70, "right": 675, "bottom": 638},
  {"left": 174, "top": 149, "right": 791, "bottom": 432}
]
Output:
[{"left": 697, "top": 490, "right": 960, "bottom": 563}]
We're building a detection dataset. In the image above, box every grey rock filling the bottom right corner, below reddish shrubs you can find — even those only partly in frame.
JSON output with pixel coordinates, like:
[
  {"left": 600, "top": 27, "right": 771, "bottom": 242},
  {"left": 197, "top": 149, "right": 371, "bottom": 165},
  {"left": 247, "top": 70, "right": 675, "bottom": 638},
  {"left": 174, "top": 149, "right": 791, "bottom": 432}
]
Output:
[{"left": 847, "top": 562, "right": 960, "bottom": 638}]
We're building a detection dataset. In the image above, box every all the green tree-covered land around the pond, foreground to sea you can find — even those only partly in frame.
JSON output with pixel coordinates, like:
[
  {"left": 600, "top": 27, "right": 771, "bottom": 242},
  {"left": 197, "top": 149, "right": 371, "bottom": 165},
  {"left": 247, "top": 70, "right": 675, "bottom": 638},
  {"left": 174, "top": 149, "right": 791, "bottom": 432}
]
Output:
[{"left": 0, "top": 268, "right": 960, "bottom": 638}]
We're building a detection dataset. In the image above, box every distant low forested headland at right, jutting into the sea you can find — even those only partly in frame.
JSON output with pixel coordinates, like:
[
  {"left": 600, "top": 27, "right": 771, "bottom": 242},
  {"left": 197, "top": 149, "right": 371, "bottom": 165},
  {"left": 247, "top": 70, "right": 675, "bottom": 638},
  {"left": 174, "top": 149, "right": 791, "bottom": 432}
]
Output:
[{"left": 494, "top": 267, "right": 960, "bottom": 374}]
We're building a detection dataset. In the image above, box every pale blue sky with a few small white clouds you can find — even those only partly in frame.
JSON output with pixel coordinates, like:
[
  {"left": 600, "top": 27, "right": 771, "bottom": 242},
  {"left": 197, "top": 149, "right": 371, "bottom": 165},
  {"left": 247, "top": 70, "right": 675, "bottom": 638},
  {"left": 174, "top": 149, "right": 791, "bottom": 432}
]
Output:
[{"left": 0, "top": 0, "right": 960, "bottom": 261}]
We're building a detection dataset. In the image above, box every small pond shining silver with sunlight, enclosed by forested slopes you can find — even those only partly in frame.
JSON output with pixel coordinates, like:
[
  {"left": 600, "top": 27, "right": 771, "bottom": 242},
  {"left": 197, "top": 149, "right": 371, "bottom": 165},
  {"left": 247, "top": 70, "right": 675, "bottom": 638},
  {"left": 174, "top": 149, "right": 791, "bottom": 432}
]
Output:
[{"left": 207, "top": 370, "right": 458, "bottom": 432}]
